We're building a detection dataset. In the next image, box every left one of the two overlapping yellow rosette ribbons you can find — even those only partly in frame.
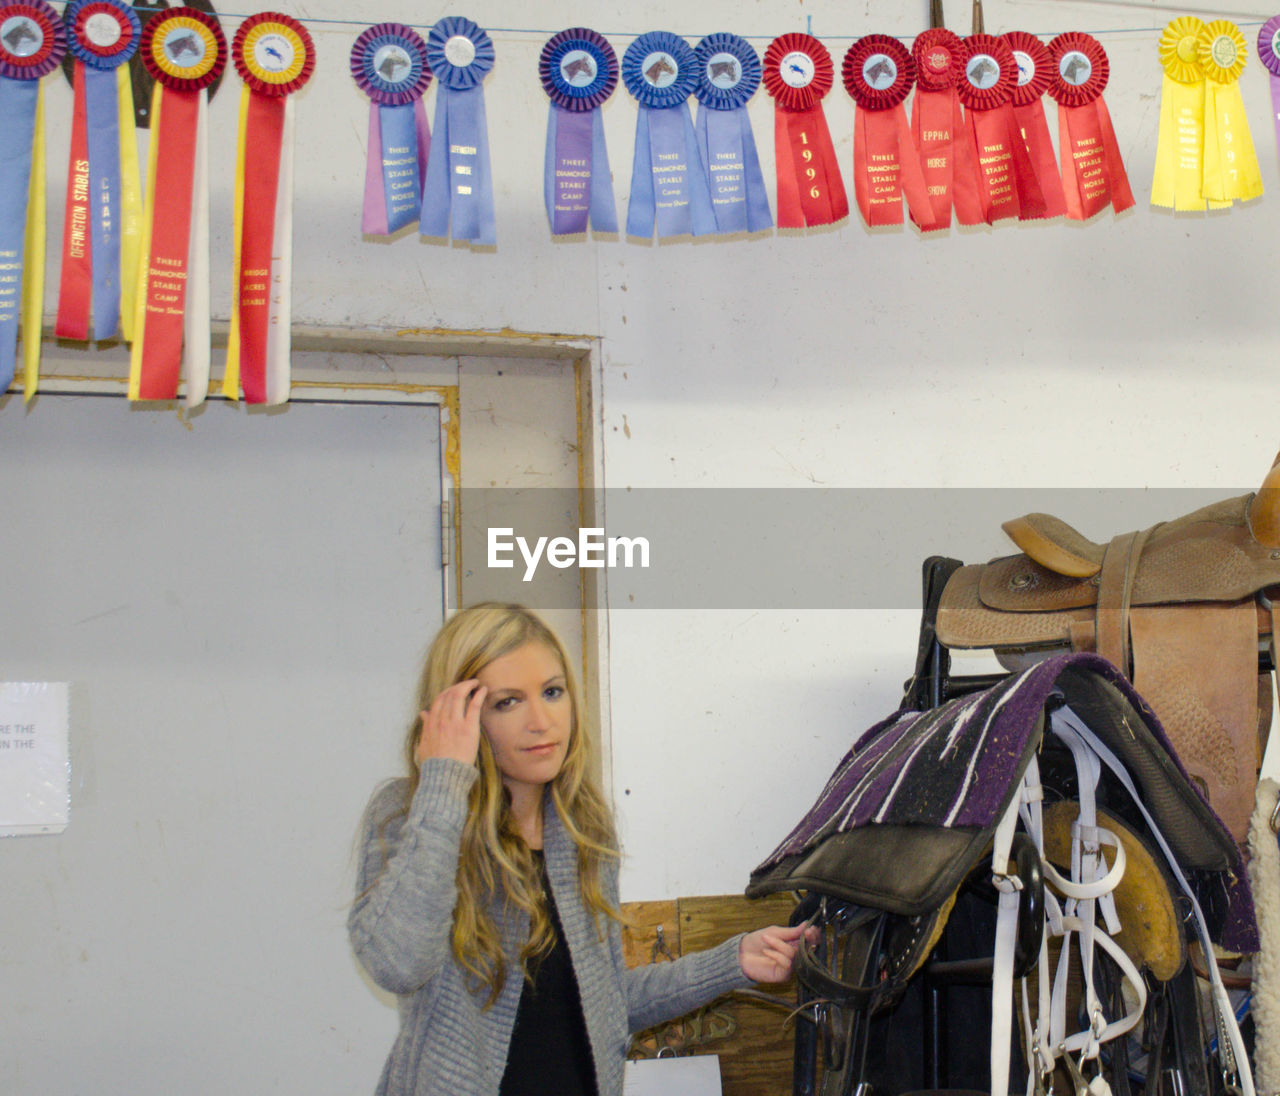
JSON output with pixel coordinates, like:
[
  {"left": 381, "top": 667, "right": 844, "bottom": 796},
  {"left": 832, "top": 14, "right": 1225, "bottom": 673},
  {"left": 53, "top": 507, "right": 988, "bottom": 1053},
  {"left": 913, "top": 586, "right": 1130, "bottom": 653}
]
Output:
[{"left": 1151, "top": 15, "right": 1208, "bottom": 210}]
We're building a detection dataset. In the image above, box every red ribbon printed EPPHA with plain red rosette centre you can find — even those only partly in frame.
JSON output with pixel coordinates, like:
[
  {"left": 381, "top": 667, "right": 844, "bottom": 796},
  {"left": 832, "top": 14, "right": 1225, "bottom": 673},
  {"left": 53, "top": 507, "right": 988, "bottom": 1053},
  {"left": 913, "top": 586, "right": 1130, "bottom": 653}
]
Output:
[{"left": 911, "top": 27, "right": 983, "bottom": 230}]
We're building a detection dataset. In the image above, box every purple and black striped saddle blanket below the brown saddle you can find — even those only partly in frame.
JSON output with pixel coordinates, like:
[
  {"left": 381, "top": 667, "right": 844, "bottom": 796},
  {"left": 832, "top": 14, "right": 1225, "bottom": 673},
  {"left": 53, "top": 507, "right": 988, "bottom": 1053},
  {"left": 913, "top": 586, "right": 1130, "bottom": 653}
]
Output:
[{"left": 746, "top": 654, "right": 1258, "bottom": 953}]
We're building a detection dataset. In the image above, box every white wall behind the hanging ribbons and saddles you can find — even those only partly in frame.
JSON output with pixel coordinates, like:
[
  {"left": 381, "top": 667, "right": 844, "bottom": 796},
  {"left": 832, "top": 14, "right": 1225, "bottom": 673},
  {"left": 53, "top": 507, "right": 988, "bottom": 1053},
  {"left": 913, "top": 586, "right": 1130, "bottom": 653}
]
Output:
[{"left": 27, "top": 0, "right": 1280, "bottom": 899}]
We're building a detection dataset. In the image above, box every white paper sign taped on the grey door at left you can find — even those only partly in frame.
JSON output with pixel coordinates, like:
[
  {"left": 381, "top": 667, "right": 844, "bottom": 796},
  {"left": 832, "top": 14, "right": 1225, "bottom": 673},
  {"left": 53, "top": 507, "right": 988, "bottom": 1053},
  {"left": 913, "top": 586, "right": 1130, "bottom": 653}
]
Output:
[{"left": 0, "top": 681, "right": 70, "bottom": 836}]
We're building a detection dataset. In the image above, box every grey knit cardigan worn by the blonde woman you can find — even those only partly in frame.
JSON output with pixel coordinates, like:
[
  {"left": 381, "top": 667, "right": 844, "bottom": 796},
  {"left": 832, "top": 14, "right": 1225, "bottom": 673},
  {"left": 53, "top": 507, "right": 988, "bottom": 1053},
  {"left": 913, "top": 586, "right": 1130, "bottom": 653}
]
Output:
[{"left": 347, "top": 759, "right": 750, "bottom": 1096}]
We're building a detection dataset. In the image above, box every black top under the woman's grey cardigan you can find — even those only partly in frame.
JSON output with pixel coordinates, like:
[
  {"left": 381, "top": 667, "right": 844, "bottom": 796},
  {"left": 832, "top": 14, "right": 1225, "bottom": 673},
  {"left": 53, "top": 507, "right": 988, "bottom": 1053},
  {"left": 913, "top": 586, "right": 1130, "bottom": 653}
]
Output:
[{"left": 499, "top": 851, "right": 596, "bottom": 1096}]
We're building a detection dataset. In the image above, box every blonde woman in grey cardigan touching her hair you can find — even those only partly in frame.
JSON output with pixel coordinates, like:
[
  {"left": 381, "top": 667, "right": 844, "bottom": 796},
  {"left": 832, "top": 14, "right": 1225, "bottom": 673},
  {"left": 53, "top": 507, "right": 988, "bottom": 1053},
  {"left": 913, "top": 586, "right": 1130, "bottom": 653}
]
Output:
[{"left": 348, "top": 604, "right": 801, "bottom": 1096}]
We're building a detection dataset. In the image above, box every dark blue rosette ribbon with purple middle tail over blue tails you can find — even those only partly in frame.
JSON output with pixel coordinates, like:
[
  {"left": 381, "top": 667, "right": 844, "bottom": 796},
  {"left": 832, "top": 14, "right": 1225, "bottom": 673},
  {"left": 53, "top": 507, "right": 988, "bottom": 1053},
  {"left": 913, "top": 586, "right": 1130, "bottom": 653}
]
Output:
[{"left": 538, "top": 27, "right": 618, "bottom": 236}]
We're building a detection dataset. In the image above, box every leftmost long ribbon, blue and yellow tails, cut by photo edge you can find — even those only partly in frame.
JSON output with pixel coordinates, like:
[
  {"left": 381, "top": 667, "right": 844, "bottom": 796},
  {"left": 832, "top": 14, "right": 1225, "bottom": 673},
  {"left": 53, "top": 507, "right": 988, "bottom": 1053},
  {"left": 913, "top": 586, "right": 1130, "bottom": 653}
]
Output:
[{"left": 0, "top": 0, "right": 67, "bottom": 399}]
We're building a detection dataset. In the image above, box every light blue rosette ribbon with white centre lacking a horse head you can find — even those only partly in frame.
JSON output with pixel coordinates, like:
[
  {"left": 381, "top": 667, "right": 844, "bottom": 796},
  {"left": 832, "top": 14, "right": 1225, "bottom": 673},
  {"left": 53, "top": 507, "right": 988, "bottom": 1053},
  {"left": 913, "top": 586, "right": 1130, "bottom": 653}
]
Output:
[{"left": 419, "top": 15, "right": 498, "bottom": 245}]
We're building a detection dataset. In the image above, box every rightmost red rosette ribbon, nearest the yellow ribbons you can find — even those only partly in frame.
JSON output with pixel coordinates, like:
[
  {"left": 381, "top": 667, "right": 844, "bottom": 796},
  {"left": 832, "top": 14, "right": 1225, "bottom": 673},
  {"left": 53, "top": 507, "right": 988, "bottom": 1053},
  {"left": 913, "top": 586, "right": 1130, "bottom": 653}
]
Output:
[{"left": 1048, "top": 32, "right": 1133, "bottom": 220}]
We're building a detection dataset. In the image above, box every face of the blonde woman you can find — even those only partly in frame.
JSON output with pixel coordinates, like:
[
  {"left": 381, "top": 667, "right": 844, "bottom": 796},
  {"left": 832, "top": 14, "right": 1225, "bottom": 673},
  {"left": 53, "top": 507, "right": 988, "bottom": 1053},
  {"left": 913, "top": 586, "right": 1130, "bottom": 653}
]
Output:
[{"left": 476, "top": 643, "right": 573, "bottom": 798}]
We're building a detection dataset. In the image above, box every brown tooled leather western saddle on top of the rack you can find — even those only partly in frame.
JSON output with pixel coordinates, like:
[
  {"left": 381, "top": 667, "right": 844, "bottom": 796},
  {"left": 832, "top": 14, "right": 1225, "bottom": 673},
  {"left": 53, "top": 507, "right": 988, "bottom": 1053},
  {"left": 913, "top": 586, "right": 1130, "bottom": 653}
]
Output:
[{"left": 936, "top": 456, "right": 1280, "bottom": 844}]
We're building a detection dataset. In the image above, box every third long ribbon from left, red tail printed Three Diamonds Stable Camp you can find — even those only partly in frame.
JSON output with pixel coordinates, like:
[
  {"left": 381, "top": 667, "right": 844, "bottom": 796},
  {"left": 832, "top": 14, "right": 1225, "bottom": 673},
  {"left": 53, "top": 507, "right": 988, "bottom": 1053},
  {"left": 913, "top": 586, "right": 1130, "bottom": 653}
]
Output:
[{"left": 129, "top": 8, "right": 227, "bottom": 407}]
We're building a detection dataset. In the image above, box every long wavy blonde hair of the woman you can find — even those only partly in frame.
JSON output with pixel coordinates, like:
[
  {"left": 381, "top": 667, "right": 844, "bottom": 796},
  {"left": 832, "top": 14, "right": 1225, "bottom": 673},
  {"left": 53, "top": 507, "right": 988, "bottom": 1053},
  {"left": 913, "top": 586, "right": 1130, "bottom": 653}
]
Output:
[{"left": 404, "top": 602, "right": 620, "bottom": 1006}]
